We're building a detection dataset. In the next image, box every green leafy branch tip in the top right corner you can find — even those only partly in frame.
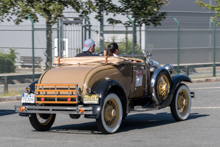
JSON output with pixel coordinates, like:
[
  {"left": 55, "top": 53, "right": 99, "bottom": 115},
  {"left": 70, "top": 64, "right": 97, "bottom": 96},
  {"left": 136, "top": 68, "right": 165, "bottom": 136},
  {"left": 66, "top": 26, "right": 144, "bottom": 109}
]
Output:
[{"left": 196, "top": 0, "right": 220, "bottom": 25}]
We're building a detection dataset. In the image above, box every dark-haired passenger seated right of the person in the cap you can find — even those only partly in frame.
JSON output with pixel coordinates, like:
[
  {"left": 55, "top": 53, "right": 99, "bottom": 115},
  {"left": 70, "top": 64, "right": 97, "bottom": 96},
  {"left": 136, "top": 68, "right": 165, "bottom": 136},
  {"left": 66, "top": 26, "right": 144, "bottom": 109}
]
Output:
[{"left": 104, "top": 43, "right": 119, "bottom": 63}]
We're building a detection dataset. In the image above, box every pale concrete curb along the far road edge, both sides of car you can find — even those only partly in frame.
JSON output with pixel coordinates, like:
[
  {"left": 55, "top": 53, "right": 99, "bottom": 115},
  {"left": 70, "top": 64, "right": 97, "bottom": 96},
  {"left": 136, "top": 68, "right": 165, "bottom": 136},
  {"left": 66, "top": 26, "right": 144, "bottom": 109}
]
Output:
[{"left": 0, "top": 77, "right": 220, "bottom": 102}]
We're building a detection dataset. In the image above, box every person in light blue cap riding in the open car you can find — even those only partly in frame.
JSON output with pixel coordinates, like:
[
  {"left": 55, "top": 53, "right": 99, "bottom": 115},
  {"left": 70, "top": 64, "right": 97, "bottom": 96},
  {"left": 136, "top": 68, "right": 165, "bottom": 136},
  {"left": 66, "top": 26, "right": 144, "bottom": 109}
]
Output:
[{"left": 76, "top": 39, "right": 98, "bottom": 57}]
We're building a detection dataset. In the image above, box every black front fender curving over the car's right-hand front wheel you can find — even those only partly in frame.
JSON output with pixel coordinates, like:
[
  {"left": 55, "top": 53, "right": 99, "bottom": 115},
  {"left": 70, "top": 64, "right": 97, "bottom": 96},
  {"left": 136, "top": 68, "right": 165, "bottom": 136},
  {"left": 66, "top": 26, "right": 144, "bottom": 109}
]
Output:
[{"left": 159, "top": 75, "right": 192, "bottom": 109}]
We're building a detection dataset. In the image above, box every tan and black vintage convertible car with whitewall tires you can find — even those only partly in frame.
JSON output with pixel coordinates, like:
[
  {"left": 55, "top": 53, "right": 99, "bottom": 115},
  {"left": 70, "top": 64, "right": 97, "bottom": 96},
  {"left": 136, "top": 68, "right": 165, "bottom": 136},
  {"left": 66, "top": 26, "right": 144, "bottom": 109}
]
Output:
[{"left": 15, "top": 55, "right": 194, "bottom": 134}]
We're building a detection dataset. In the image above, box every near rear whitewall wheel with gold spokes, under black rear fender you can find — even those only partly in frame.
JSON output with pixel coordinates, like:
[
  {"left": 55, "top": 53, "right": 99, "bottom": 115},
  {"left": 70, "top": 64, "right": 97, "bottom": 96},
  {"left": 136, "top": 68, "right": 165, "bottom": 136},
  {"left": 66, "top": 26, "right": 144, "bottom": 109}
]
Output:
[{"left": 96, "top": 93, "right": 123, "bottom": 134}]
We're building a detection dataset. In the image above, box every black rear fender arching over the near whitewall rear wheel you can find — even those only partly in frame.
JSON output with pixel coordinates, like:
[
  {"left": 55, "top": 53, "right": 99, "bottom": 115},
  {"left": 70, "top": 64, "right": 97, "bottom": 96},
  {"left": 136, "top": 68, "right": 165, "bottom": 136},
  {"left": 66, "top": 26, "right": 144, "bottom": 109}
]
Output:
[{"left": 92, "top": 80, "right": 128, "bottom": 119}]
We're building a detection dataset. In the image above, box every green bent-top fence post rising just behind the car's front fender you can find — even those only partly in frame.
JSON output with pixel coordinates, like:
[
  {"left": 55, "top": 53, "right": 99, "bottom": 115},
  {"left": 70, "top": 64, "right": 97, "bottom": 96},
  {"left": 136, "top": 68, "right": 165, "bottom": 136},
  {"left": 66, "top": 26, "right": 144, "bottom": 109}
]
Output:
[{"left": 173, "top": 17, "right": 180, "bottom": 74}]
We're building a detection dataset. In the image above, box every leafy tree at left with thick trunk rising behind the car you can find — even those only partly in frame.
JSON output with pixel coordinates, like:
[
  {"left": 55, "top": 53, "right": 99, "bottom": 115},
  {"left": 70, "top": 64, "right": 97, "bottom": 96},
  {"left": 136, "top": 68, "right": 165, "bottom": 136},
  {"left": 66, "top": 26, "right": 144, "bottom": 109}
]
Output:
[{"left": 0, "top": 0, "right": 84, "bottom": 69}]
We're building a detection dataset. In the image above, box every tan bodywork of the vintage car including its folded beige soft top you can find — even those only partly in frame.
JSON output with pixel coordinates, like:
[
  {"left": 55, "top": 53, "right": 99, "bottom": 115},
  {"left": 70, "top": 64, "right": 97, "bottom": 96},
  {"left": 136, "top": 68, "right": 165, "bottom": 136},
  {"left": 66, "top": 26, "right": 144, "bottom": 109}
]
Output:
[{"left": 38, "top": 57, "right": 147, "bottom": 98}]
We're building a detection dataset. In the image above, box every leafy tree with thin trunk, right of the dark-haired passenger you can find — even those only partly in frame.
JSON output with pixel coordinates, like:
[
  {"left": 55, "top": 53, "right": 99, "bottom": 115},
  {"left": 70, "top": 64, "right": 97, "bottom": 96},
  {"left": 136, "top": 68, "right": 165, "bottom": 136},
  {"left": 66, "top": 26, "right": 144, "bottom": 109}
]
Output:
[{"left": 84, "top": 0, "right": 169, "bottom": 52}]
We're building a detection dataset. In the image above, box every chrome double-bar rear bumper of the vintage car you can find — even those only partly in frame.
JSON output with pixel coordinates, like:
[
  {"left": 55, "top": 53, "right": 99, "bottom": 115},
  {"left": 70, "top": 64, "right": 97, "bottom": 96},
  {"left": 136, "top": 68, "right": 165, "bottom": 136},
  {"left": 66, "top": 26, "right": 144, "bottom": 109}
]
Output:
[{"left": 15, "top": 106, "right": 93, "bottom": 114}]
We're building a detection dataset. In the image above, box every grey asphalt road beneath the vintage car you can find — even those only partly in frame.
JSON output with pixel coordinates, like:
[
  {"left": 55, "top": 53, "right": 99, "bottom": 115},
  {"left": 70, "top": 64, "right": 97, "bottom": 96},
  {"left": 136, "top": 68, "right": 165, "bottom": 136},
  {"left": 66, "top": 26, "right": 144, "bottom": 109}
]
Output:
[{"left": 0, "top": 82, "right": 220, "bottom": 147}]
